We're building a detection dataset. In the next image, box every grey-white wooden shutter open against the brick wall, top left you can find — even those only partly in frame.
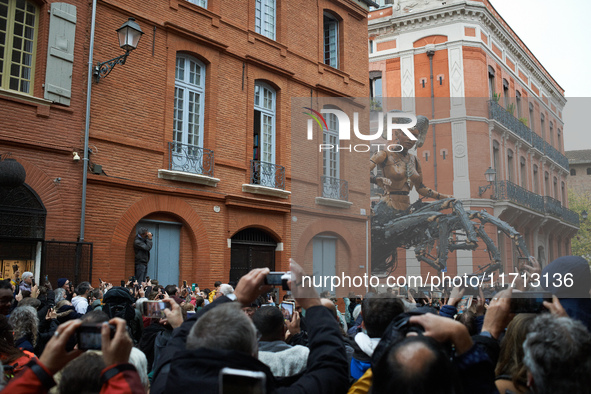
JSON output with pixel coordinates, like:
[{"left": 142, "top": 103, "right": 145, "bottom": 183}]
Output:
[{"left": 45, "top": 3, "right": 76, "bottom": 105}]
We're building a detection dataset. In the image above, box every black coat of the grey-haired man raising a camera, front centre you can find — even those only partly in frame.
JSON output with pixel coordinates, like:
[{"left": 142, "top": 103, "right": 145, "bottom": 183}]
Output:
[{"left": 150, "top": 297, "right": 349, "bottom": 394}]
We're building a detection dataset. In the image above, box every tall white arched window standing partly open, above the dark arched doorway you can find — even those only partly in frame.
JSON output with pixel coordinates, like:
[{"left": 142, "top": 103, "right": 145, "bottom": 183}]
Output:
[{"left": 253, "top": 82, "right": 277, "bottom": 187}]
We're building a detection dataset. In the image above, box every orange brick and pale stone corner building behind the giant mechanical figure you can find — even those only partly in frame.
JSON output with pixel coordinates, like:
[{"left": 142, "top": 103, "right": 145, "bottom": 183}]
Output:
[{"left": 369, "top": 0, "right": 578, "bottom": 275}]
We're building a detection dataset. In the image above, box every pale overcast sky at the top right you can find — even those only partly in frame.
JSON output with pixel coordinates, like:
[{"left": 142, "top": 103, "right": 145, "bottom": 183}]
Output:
[{"left": 490, "top": 0, "right": 591, "bottom": 150}]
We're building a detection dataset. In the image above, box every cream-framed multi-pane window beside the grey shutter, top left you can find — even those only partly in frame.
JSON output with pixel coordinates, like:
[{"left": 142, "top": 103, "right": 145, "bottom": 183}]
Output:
[{"left": 0, "top": 0, "right": 39, "bottom": 94}]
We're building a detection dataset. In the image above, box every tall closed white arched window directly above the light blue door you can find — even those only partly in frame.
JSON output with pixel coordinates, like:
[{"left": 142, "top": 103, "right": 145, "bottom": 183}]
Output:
[{"left": 173, "top": 54, "right": 205, "bottom": 172}]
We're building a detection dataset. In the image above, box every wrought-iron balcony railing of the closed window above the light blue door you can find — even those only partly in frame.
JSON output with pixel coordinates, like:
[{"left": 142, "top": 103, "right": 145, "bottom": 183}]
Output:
[{"left": 168, "top": 142, "right": 214, "bottom": 177}]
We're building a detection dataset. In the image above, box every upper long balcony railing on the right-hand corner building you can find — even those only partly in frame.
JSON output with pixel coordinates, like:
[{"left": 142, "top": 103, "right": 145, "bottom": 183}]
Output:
[{"left": 488, "top": 100, "right": 568, "bottom": 171}]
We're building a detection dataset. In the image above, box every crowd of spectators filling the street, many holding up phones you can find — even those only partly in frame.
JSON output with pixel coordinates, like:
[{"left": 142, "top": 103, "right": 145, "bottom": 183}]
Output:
[{"left": 0, "top": 256, "right": 591, "bottom": 394}]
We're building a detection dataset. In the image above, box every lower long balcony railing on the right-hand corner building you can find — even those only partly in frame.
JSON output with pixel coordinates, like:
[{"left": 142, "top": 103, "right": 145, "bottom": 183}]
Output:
[{"left": 494, "top": 181, "right": 579, "bottom": 227}]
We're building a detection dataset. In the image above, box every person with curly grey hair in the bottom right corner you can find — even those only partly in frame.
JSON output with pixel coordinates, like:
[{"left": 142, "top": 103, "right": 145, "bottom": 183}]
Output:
[{"left": 523, "top": 314, "right": 591, "bottom": 394}]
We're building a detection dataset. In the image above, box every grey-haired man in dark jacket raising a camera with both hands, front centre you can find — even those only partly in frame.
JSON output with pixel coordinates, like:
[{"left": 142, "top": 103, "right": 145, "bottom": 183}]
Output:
[{"left": 150, "top": 262, "right": 348, "bottom": 394}]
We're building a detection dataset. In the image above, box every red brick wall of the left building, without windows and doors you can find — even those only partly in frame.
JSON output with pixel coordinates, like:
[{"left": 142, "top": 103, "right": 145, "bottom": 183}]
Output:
[{"left": 0, "top": 0, "right": 369, "bottom": 288}]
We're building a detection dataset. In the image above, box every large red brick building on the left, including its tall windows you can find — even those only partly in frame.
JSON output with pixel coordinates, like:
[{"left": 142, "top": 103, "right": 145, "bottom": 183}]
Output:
[{"left": 0, "top": 0, "right": 369, "bottom": 287}]
